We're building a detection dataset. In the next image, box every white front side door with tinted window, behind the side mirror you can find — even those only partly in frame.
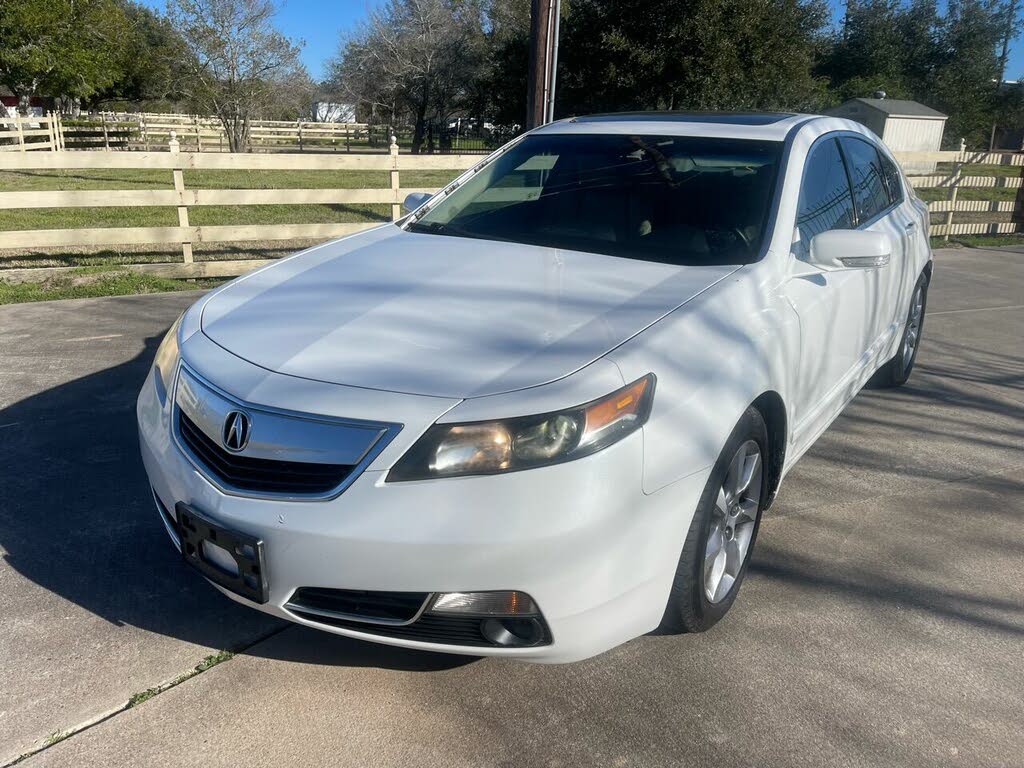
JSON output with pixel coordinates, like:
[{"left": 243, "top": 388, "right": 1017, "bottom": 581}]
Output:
[{"left": 785, "top": 134, "right": 878, "bottom": 444}]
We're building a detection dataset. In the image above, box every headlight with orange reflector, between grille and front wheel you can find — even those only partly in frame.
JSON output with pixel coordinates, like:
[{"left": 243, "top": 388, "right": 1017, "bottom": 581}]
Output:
[{"left": 387, "top": 374, "right": 654, "bottom": 482}]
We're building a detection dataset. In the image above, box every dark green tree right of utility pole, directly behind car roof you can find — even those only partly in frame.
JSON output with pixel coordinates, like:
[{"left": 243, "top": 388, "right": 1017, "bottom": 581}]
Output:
[{"left": 556, "top": 0, "right": 827, "bottom": 115}]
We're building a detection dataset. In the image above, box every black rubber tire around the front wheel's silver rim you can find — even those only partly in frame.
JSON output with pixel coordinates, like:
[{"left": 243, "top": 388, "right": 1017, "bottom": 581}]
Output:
[{"left": 660, "top": 408, "right": 768, "bottom": 633}]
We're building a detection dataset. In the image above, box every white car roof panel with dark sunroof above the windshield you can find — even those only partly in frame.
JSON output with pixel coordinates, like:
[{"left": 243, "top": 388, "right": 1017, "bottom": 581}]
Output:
[{"left": 536, "top": 112, "right": 819, "bottom": 141}]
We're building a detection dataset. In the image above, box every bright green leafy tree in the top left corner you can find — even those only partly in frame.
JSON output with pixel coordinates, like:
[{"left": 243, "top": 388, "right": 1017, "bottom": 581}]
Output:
[{"left": 0, "top": 0, "right": 130, "bottom": 110}]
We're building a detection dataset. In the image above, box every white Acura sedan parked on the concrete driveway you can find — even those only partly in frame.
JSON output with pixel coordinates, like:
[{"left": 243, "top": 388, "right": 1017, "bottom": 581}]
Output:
[{"left": 138, "top": 113, "right": 932, "bottom": 662}]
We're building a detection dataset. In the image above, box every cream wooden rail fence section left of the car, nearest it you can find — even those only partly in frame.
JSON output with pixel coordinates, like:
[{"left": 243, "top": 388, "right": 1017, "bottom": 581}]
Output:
[{"left": 0, "top": 137, "right": 480, "bottom": 282}]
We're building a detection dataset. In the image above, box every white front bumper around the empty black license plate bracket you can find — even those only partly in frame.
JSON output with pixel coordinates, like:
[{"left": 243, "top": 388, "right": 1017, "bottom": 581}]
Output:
[{"left": 137, "top": 348, "right": 707, "bottom": 662}]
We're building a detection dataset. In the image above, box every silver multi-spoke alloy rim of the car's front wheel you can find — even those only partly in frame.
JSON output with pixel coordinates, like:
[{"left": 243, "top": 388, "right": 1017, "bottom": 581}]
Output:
[{"left": 703, "top": 440, "right": 764, "bottom": 603}]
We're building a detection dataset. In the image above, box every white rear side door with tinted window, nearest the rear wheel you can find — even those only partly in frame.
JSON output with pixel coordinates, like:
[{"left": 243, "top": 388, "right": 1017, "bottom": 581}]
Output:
[{"left": 840, "top": 134, "right": 916, "bottom": 354}]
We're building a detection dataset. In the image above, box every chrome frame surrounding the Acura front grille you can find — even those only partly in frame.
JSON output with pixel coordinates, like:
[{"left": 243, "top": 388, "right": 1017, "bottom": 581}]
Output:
[{"left": 170, "top": 360, "right": 404, "bottom": 502}]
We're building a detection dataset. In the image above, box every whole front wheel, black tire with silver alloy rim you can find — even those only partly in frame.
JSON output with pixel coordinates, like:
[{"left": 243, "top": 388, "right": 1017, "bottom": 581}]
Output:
[{"left": 663, "top": 408, "right": 768, "bottom": 632}]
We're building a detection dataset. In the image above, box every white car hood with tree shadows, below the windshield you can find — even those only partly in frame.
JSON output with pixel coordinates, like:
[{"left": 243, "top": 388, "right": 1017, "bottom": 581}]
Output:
[{"left": 202, "top": 225, "right": 735, "bottom": 397}]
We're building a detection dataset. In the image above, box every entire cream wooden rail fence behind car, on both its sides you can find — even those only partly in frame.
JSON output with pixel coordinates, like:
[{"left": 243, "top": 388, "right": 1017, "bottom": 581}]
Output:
[{"left": 0, "top": 143, "right": 1024, "bottom": 281}]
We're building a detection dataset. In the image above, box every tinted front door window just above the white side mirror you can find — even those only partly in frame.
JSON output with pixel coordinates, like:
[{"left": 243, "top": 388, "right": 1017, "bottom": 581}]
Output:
[{"left": 797, "top": 138, "right": 853, "bottom": 243}]
